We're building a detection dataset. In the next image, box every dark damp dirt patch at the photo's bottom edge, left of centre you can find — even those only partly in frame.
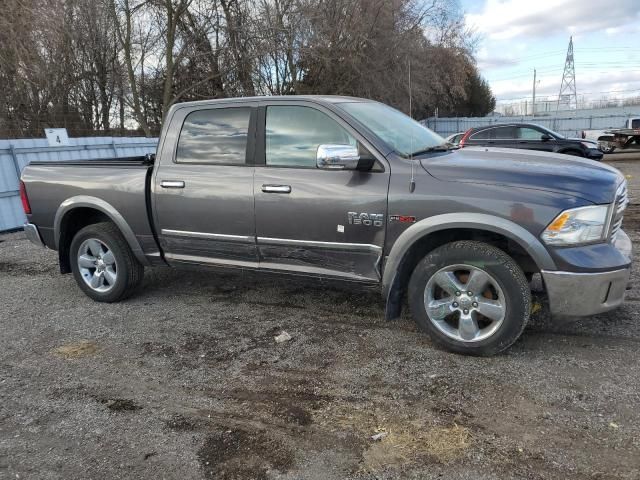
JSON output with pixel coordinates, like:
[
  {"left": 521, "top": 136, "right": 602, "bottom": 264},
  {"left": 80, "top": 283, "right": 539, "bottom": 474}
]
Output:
[{"left": 198, "top": 430, "right": 293, "bottom": 480}]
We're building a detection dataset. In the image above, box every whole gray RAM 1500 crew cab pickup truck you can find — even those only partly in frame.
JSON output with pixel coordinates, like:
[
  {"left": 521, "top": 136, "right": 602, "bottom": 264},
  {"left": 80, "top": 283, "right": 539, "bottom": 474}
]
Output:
[{"left": 21, "top": 96, "right": 631, "bottom": 355}]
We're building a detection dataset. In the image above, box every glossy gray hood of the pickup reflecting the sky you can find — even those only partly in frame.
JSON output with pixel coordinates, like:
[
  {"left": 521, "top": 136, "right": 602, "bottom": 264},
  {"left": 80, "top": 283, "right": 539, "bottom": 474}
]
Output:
[{"left": 421, "top": 147, "right": 624, "bottom": 203}]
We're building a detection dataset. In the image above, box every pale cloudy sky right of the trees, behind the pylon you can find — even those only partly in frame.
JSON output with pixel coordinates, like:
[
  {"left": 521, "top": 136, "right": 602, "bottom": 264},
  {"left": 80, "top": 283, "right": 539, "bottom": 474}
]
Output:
[{"left": 461, "top": 0, "right": 640, "bottom": 101}]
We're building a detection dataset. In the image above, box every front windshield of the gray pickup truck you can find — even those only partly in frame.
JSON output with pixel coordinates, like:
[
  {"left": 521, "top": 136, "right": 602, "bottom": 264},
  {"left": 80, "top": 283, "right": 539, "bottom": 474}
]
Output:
[{"left": 339, "top": 102, "right": 446, "bottom": 157}]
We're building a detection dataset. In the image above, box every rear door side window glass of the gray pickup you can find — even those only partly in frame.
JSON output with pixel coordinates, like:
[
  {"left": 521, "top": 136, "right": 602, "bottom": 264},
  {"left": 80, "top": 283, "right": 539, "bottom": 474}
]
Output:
[{"left": 176, "top": 107, "right": 251, "bottom": 165}]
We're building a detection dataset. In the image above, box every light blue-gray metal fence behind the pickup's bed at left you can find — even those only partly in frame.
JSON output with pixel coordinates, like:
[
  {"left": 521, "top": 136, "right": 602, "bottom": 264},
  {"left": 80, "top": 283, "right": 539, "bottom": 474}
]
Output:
[{"left": 0, "top": 137, "right": 158, "bottom": 232}]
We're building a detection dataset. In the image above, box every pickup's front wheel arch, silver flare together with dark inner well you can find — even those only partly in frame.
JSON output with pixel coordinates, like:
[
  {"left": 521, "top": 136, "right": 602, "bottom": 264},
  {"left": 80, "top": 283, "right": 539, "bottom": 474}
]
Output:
[{"left": 382, "top": 213, "right": 557, "bottom": 319}]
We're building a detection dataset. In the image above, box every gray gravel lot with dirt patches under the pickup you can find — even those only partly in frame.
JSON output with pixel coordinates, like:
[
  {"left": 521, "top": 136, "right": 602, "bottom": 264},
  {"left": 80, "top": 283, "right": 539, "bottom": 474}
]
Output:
[{"left": 0, "top": 159, "right": 640, "bottom": 480}]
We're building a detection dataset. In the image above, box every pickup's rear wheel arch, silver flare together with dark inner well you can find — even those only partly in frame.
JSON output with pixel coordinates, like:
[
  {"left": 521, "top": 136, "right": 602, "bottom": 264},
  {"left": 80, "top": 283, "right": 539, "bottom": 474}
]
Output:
[{"left": 53, "top": 195, "right": 149, "bottom": 273}]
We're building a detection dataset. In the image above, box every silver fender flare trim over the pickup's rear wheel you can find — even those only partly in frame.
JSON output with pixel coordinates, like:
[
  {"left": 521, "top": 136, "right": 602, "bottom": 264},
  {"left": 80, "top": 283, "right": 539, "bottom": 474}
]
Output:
[{"left": 53, "top": 195, "right": 149, "bottom": 265}]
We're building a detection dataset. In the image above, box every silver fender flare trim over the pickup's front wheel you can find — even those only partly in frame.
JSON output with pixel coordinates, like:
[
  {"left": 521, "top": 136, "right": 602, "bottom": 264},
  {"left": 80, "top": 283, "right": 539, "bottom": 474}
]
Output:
[{"left": 382, "top": 213, "right": 557, "bottom": 302}]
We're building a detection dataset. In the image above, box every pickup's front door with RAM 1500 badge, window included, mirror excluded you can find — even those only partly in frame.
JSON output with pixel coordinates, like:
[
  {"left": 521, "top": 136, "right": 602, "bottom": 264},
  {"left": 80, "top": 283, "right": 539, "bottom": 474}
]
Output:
[{"left": 254, "top": 101, "right": 389, "bottom": 281}]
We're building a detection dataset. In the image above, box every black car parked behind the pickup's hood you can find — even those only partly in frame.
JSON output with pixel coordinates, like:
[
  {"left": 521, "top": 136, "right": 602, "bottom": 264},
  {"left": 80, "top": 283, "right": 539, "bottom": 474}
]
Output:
[{"left": 460, "top": 123, "right": 603, "bottom": 160}]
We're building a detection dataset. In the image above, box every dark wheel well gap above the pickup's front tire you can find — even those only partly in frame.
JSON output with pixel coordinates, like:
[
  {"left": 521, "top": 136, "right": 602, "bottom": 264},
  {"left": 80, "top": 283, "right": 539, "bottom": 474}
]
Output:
[{"left": 387, "top": 228, "right": 540, "bottom": 318}]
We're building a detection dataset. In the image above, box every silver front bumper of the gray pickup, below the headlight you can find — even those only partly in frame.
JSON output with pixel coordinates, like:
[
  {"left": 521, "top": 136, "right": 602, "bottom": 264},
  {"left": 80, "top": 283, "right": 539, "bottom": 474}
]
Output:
[{"left": 542, "top": 230, "right": 632, "bottom": 317}]
